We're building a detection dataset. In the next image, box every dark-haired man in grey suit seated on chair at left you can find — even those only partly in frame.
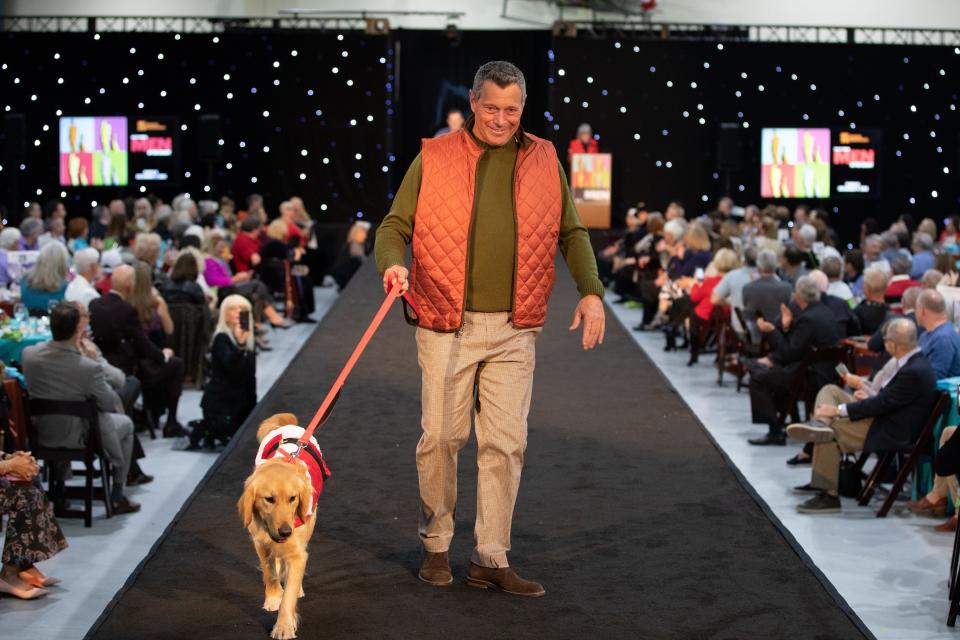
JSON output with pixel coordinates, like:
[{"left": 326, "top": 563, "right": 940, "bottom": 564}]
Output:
[{"left": 23, "top": 302, "right": 140, "bottom": 514}]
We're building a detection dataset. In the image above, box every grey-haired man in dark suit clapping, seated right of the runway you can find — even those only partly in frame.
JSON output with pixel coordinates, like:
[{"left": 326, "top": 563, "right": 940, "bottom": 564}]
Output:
[{"left": 747, "top": 276, "right": 840, "bottom": 445}]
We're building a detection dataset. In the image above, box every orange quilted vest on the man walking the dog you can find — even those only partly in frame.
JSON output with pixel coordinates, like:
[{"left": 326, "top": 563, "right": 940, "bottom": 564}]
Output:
[{"left": 410, "top": 129, "right": 563, "bottom": 331}]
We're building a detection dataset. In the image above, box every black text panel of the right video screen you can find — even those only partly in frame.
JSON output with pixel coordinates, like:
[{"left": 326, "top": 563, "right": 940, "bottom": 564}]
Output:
[{"left": 831, "top": 129, "right": 881, "bottom": 198}]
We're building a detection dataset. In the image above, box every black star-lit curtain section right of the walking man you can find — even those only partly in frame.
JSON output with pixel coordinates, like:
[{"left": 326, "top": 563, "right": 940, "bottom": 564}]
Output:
[{"left": 544, "top": 38, "right": 960, "bottom": 241}]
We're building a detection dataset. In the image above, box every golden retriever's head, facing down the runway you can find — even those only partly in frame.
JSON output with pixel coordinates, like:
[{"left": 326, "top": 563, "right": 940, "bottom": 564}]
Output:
[{"left": 237, "top": 459, "right": 313, "bottom": 542}]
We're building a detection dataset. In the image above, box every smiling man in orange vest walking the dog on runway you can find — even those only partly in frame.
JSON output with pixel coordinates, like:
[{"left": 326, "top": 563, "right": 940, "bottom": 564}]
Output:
[{"left": 376, "top": 61, "right": 604, "bottom": 596}]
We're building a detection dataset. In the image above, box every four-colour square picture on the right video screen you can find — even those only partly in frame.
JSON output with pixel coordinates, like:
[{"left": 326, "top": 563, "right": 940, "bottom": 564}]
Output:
[{"left": 760, "top": 128, "right": 830, "bottom": 198}]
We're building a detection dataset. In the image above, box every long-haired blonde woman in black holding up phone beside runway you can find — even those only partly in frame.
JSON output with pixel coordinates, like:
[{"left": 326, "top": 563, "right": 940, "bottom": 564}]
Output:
[{"left": 189, "top": 295, "right": 257, "bottom": 449}]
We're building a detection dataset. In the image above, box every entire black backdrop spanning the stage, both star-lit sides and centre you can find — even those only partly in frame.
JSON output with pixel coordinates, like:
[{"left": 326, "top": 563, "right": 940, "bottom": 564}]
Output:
[{"left": 0, "top": 30, "right": 960, "bottom": 245}]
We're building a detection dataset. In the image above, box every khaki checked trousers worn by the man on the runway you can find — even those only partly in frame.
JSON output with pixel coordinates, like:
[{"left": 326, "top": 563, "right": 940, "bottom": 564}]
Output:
[{"left": 417, "top": 311, "right": 540, "bottom": 568}]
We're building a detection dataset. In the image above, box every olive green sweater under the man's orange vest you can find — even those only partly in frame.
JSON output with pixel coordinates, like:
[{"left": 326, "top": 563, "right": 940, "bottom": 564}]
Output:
[{"left": 375, "top": 126, "right": 604, "bottom": 312}]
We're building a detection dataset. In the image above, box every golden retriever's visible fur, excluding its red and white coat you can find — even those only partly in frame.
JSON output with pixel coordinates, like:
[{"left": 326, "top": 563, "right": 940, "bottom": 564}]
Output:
[{"left": 237, "top": 413, "right": 317, "bottom": 640}]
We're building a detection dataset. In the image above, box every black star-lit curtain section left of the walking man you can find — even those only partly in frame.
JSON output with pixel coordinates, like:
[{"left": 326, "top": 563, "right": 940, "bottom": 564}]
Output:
[{"left": 0, "top": 31, "right": 394, "bottom": 222}]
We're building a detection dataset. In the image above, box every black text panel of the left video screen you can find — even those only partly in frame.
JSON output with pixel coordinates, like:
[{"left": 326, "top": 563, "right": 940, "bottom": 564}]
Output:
[{"left": 130, "top": 117, "right": 180, "bottom": 183}]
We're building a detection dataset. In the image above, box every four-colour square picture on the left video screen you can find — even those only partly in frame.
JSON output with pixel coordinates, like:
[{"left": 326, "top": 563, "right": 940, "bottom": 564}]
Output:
[{"left": 60, "top": 116, "right": 128, "bottom": 187}]
